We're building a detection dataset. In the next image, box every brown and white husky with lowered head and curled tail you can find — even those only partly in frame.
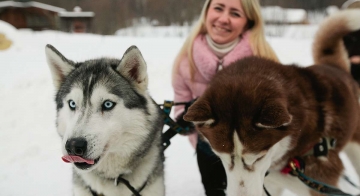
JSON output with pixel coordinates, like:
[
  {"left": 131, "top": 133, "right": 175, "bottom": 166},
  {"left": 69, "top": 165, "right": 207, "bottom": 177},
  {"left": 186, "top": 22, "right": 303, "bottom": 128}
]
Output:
[{"left": 184, "top": 10, "right": 360, "bottom": 196}]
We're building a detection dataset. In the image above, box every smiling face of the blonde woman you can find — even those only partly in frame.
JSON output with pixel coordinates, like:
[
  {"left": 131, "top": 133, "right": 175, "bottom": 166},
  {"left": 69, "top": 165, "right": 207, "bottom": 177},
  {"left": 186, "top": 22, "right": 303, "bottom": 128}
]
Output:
[{"left": 205, "top": 0, "right": 247, "bottom": 44}]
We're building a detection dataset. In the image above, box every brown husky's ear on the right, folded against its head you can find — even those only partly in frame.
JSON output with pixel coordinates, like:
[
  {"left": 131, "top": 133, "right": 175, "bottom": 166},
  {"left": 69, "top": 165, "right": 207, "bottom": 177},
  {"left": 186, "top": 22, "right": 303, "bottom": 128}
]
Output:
[{"left": 255, "top": 101, "right": 292, "bottom": 129}]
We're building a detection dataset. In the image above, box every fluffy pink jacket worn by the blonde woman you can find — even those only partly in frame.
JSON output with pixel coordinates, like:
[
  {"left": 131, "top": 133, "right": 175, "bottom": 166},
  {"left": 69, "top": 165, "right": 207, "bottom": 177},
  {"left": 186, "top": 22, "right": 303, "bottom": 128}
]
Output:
[{"left": 172, "top": 32, "right": 253, "bottom": 148}]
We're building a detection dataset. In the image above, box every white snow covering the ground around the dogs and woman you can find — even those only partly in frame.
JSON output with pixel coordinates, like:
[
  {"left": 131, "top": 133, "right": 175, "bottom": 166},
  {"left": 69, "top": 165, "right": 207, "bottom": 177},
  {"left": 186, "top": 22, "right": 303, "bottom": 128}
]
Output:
[{"left": 0, "top": 21, "right": 357, "bottom": 196}]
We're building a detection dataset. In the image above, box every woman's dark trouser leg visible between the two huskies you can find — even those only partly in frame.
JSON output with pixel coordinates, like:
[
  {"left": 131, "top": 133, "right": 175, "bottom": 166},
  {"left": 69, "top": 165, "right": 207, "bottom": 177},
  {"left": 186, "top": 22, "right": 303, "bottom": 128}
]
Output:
[{"left": 196, "top": 139, "right": 226, "bottom": 196}]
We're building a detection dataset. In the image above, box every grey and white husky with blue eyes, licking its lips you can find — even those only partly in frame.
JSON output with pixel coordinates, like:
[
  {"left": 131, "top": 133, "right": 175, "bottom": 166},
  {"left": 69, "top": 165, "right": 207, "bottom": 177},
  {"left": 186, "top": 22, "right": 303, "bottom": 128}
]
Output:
[{"left": 45, "top": 45, "right": 165, "bottom": 196}]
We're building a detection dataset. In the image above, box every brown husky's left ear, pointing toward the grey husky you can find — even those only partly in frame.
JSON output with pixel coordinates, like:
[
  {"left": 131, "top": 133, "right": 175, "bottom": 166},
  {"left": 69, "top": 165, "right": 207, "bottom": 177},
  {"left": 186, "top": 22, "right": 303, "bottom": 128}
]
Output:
[{"left": 183, "top": 99, "right": 215, "bottom": 126}]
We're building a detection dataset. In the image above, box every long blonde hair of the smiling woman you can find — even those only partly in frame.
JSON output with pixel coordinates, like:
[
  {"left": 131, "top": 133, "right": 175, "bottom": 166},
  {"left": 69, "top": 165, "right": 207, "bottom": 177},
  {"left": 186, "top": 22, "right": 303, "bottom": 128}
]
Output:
[{"left": 173, "top": 0, "right": 279, "bottom": 80}]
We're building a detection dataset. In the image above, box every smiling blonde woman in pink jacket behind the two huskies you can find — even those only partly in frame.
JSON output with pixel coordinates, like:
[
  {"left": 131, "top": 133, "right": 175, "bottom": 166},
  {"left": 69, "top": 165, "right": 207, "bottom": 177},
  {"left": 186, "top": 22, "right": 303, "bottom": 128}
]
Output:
[{"left": 172, "top": 0, "right": 278, "bottom": 196}]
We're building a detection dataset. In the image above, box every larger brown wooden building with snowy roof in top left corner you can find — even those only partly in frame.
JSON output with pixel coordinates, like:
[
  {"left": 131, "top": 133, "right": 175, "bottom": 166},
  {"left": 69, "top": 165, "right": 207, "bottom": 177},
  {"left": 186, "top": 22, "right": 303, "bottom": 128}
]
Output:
[{"left": 0, "top": 1, "right": 65, "bottom": 30}]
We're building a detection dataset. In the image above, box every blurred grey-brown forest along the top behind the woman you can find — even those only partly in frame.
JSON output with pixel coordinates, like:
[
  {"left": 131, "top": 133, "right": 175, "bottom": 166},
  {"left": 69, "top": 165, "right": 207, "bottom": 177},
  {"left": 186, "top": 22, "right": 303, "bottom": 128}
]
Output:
[{"left": 0, "top": 0, "right": 345, "bottom": 35}]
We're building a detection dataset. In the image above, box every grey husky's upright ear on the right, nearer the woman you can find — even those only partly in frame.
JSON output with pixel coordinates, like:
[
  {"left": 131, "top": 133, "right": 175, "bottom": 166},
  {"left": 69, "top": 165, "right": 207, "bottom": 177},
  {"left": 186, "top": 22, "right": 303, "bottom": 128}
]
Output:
[{"left": 117, "top": 46, "right": 148, "bottom": 92}]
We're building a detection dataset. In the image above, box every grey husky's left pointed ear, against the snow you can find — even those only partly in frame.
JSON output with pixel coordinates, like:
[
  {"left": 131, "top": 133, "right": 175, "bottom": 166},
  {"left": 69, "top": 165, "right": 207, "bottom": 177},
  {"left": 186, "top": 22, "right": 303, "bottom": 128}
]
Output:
[{"left": 45, "top": 44, "right": 75, "bottom": 89}]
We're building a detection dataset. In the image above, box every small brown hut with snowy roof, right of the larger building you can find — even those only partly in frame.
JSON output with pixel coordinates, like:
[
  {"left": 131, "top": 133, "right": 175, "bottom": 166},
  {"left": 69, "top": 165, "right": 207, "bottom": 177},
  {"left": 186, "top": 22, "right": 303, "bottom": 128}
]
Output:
[{"left": 59, "top": 6, "right": 95, "bottom": 33}]
